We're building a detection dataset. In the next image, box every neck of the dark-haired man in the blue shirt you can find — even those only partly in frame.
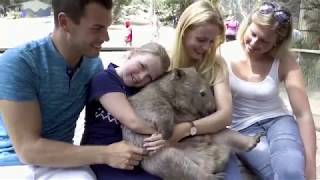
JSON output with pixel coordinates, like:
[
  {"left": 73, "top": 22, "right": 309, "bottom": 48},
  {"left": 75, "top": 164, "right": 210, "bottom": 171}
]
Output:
[{"left": 51, "top": 29, "right": 82, "bottom": 67}]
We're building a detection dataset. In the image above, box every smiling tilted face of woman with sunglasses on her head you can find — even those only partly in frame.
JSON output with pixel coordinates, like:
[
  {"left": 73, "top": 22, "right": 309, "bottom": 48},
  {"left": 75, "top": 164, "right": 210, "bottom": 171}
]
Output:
[{"left": 243, "top": 23, "right": 277, "bottom": 55}]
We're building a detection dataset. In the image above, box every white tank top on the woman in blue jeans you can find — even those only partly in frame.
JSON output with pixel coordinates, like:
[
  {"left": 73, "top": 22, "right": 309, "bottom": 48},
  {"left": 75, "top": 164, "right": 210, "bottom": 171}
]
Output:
[{"left": 227, "top": 59, "right": 292, "bottom": 130}]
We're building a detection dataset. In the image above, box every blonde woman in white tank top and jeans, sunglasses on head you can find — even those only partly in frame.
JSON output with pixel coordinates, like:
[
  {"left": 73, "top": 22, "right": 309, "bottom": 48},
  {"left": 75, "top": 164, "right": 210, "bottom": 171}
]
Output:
[{"left": 222, "top": 2, "right": 316, "bottom": 180}]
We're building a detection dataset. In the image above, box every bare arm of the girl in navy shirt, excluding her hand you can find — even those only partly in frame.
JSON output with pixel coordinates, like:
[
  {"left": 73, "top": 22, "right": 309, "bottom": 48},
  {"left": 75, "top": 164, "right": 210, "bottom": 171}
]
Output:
[{"left": 99, "top": 92, "right": 155, "bottom": 134}]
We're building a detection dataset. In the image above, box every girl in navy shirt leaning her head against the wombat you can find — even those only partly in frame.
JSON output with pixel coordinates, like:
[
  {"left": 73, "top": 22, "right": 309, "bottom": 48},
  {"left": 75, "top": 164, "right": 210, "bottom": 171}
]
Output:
[{"left": 82, "top": 43, "right": 170, "bottom": 180}]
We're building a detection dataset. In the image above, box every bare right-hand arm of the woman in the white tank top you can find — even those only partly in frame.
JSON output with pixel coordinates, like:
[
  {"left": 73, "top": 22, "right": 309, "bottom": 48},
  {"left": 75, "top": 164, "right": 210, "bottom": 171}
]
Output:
[{"left": 280, "top": 52, "right": 316, "bottom": 179}]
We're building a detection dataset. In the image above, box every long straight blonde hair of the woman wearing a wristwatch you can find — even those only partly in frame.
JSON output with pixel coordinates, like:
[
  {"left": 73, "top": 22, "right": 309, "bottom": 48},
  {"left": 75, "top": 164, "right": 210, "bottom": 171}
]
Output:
[{"left": 170, "top": 0, "right": 227, "bottom": 84}]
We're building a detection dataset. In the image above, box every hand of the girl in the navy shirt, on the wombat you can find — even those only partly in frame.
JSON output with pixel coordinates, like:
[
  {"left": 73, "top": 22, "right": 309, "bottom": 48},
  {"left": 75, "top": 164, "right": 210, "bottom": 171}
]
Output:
[{"left": 143, "top": 133, "right": 166, "bottom": 153}]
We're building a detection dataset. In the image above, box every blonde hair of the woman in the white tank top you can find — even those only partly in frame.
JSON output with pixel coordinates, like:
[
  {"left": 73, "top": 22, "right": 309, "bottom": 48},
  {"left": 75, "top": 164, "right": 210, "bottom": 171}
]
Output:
[{"left": 237, "top": 1, "right": 293, "bottom": 59}]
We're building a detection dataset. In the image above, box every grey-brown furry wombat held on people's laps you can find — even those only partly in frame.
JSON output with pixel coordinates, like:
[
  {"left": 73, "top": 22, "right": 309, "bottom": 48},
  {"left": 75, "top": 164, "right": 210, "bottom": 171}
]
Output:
[{"left": 122, "top": 68, "right": 259, "bottom": 180}]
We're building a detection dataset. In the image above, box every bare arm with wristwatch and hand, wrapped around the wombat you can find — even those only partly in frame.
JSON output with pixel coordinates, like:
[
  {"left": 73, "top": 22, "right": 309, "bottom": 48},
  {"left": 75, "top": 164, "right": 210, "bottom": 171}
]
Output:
[{"left": 170, "top": 71, "right": 232, "bottom": 142}]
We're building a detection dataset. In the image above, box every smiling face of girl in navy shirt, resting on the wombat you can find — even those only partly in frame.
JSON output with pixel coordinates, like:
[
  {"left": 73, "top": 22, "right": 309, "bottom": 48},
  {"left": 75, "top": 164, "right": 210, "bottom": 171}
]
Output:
[{"left": 122, "top": 53, "right": 164, "bottom": 87}]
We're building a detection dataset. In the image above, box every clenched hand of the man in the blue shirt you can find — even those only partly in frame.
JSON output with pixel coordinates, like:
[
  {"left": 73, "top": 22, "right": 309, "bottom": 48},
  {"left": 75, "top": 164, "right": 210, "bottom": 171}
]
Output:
[{"left": 106, "top": 141, "right": 145, "bottom": 170}]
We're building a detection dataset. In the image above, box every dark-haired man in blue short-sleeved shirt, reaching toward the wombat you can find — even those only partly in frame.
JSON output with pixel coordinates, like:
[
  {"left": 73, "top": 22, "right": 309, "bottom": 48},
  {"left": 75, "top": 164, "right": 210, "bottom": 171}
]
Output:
[{"left": 0, "top": 0, "right": 143, "bottom": 180}]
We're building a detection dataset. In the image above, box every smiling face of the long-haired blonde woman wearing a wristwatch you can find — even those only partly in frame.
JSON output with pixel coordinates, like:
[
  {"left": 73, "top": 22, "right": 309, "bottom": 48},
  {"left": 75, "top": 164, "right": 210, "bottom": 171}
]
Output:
[{"left": 183, "top": 23, "right": 221, "bottom": 62}]
